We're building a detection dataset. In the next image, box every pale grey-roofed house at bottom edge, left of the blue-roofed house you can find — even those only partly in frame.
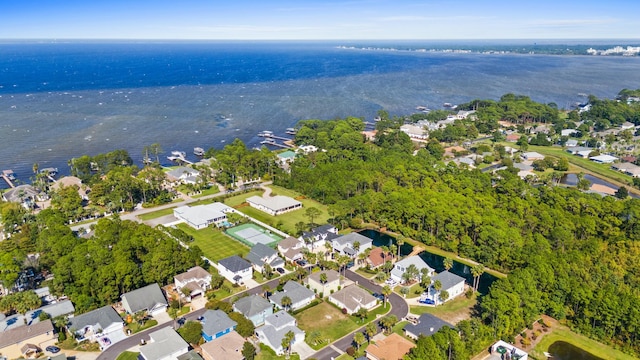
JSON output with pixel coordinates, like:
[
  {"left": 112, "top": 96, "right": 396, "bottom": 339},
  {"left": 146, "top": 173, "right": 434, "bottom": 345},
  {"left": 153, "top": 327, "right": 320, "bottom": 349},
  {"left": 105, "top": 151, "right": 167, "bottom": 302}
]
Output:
[{"left": 139, "top": 327, "right": 189, "bottom": 360}]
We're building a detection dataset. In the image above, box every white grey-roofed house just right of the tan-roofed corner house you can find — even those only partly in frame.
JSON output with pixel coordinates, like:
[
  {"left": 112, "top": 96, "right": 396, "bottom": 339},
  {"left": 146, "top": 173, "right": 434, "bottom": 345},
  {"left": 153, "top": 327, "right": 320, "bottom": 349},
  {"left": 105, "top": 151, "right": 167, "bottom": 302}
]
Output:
[{"left": 67, "top": 305, "right": 126, "bottom": 350}]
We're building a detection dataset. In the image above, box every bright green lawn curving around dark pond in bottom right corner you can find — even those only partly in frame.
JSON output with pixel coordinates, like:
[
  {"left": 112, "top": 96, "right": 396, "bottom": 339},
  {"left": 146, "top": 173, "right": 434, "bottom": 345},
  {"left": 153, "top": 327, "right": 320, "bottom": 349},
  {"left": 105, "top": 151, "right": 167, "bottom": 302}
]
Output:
[{"left": 530, "top": 327, "right": 636, "bottom": 360}]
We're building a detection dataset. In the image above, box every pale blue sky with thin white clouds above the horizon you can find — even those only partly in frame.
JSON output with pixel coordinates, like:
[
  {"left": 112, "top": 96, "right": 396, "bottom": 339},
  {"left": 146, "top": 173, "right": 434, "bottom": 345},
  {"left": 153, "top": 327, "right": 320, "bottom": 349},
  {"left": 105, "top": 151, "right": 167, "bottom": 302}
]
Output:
[{"left": 0, "top": 0, "right": 640, "bottom": 40}]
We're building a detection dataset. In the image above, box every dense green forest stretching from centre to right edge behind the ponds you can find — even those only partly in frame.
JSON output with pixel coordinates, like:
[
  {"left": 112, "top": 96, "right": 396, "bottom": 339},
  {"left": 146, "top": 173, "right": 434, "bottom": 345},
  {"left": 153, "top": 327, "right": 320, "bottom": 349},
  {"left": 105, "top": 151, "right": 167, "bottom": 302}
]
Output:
[{"left": 280, "top": 119, "right": 640, "bottom": 352}]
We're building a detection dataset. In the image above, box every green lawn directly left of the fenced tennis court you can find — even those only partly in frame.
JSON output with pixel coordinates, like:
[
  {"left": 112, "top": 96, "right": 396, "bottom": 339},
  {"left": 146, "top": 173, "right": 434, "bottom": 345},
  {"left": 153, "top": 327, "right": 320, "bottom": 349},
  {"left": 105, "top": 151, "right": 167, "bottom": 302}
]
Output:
[{"left": 176, "top": 224, "right": 249, "bottom": 262}]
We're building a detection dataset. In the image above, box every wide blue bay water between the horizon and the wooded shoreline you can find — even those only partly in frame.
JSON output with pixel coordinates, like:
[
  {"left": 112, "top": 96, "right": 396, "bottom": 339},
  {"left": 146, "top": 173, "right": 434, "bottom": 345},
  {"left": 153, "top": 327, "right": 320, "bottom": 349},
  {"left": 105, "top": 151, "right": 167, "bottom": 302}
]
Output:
[{"left": 0, "top": 42, "right": 640, "bottom": 181}]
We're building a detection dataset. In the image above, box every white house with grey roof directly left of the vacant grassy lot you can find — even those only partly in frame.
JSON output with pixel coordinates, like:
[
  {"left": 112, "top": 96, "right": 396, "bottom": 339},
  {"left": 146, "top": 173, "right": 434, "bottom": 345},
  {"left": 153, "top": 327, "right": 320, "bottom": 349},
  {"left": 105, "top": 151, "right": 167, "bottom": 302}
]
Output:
[{"left": 256, "top": 311, "right": 305, "bottom": 355}]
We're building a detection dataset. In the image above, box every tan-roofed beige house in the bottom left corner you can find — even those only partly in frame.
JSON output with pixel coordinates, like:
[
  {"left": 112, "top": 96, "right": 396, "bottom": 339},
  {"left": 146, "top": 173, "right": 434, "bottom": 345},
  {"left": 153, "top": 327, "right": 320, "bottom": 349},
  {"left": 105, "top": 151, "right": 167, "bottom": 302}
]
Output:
[{"left": 0, "top": 319, "right": 57, "bottom": 359}]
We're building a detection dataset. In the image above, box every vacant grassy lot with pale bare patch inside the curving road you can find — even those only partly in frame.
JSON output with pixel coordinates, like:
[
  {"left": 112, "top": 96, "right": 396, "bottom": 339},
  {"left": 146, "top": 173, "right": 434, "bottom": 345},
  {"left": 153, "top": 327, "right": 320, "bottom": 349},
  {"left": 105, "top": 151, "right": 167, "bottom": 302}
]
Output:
[{"left": 294, "top": 302, "right": 362, "bottom": 350}]
